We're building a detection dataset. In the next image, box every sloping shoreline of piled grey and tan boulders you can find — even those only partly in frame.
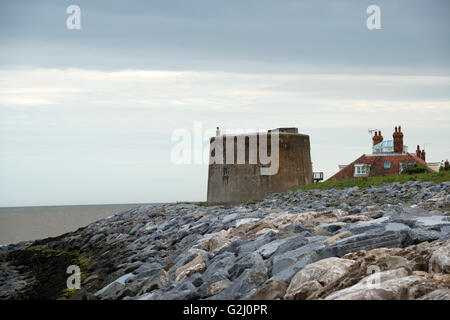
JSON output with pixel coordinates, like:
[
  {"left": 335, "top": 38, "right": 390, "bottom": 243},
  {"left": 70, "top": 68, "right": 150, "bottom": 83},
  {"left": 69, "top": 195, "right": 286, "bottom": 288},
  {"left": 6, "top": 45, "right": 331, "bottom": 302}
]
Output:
[{"left": 0, "top": 181, "right": 450, "bottom": 300}]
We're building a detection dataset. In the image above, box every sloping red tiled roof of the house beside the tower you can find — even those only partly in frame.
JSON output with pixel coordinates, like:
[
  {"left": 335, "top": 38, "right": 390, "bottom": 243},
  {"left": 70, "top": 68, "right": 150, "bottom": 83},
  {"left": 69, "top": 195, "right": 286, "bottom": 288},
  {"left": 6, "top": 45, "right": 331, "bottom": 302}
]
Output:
[{"left": 328, "top": 153, "right": 433, "bottom": 180}]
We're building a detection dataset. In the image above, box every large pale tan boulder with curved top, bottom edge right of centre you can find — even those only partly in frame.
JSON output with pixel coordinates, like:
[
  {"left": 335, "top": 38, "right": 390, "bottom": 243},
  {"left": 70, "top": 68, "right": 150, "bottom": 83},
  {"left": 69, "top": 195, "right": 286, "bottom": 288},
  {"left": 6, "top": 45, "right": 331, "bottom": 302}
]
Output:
[{"left": 284, "top": 258, "right": 355, "bottom": 300}]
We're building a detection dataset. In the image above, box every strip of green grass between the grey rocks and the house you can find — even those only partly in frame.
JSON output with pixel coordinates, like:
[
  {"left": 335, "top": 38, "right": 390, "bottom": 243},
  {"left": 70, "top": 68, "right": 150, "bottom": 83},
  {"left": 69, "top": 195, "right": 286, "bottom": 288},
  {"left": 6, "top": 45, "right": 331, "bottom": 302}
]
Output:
[{"left": 297, "top": 171, "right": 450, "bottom": 190}]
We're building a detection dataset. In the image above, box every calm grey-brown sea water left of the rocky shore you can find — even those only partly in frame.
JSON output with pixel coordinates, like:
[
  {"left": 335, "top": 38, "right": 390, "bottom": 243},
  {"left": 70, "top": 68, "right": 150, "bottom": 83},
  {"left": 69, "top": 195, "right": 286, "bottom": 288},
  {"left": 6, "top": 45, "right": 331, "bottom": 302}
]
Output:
[{"left": 0, "top": 204, "right": 142, "bottom": 245}]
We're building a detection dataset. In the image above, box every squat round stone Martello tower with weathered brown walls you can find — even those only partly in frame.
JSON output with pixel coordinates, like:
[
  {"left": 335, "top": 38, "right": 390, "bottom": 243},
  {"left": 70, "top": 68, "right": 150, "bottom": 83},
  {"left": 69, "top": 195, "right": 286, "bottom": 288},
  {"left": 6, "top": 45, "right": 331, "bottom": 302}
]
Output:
[{"left": 207, "top": 128, "right": 312, "bottom": 204}]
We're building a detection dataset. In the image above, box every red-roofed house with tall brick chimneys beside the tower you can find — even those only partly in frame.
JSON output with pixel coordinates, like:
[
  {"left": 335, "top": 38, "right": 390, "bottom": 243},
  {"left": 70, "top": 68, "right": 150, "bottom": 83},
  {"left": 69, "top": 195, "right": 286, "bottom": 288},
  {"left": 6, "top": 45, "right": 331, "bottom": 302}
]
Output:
[{"left": 328, "top": 126, "right": 433, "bottom": 180}]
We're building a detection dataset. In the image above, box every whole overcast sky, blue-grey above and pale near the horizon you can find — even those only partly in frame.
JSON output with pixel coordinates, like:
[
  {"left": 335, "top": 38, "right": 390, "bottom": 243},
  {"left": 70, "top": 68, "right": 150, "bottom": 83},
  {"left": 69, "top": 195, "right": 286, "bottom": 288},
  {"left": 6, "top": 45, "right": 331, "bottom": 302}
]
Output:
[{"left": 0, "top": 0, "right": 450, "bottom": 206}]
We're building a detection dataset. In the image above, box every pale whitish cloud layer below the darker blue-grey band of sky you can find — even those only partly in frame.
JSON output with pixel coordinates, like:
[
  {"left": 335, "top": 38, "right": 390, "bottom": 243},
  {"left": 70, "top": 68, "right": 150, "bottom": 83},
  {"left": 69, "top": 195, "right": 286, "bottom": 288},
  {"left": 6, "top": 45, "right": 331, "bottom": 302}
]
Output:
[{"left": 0, "top": 68, "right": 450, "bottom": 205}]
